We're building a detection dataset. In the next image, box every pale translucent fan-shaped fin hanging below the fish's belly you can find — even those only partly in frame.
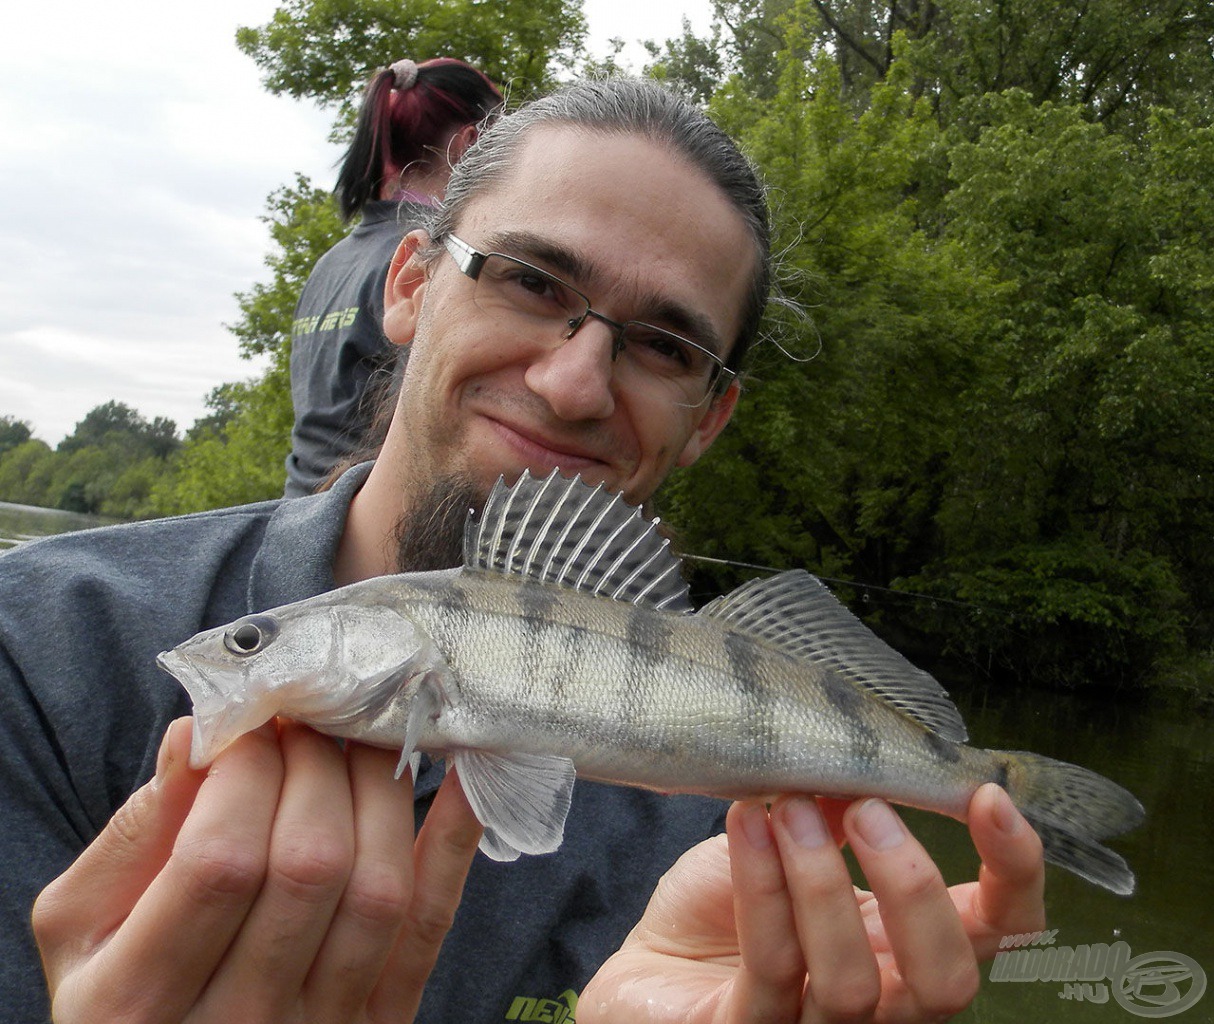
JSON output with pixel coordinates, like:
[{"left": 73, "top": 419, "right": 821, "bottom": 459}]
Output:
[{"left": 453, "top": 749, "right": 574, "bottom": 860}]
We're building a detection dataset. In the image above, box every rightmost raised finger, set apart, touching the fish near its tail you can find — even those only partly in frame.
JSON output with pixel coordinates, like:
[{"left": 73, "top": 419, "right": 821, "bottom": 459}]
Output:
[{"left": 963, "top": 782, "right": 1045, "bottom": 960}]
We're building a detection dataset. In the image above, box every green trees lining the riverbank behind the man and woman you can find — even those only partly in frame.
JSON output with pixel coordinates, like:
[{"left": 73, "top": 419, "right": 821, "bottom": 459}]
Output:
[{"left": 0, "top": 0, "right": 1214, "bottom": 694}]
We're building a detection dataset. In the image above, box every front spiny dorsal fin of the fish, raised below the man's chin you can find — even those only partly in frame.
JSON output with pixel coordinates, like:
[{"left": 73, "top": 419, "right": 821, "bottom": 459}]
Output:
[{"left": 464, "top": 470, "right": 692, "bottom": 615}]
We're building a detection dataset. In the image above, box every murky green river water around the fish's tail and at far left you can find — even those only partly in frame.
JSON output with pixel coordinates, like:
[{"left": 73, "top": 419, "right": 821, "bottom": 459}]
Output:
[{"left": 0, "top": 502, "right": 1214, "bottom": 1024}]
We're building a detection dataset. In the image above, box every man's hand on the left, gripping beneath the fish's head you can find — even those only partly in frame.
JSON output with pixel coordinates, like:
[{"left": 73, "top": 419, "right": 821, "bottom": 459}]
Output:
[{"left": 34, "top": 719, "right": 481, "bottom": 1024}]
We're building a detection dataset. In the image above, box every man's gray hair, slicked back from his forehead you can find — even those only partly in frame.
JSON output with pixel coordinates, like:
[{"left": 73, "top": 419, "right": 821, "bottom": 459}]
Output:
[{"left": 431, "top": 77, "right": 771, "bottom": 369}]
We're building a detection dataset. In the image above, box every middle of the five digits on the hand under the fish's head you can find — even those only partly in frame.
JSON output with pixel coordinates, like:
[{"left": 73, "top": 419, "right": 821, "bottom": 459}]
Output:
[{"left": 204, "top": 722, "right": 354, "bottom": 1020}]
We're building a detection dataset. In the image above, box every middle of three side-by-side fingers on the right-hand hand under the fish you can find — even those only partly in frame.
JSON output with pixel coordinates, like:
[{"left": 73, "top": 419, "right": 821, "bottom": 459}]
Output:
[{"left": 772, "top": 796, "right": 881, "bottom": 1020}]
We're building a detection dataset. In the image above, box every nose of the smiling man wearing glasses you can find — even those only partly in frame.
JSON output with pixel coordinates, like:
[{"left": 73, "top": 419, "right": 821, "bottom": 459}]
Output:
[{"left": 524, "top": 317, "right": 617, "bottom": 422}]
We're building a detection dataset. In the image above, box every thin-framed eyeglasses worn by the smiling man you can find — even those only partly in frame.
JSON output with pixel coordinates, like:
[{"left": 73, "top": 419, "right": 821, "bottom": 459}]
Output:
[{"left": 443, "top": 234, "right": 737, "bottom": 408}]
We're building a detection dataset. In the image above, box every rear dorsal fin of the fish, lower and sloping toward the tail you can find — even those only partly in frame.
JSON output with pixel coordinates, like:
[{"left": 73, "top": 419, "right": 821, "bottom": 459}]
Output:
[{"left": 699, "top": 568, "right": 968, "bottom": 742}]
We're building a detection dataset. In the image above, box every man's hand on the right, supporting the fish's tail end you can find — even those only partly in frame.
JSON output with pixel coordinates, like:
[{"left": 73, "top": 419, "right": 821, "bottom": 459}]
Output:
[{"left": 578, "top": 785, "right": 1045, "bottom": 1024}]
